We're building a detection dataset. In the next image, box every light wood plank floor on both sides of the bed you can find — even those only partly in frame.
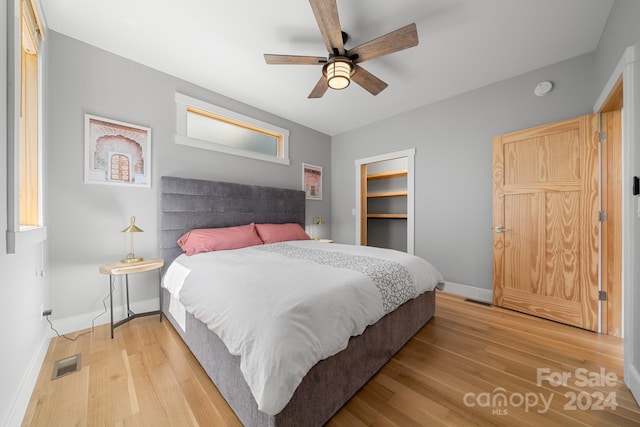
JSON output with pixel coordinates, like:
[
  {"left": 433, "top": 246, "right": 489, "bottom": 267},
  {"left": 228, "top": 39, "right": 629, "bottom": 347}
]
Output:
[{"left": 23, "top": 292, "right": 640, "bottom": 427}]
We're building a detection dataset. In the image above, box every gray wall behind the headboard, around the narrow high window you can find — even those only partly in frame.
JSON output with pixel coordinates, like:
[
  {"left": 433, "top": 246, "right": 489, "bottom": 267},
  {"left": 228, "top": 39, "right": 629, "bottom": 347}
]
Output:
[{"left": 45, "top": 32, "right": 332, "bottom": 320}]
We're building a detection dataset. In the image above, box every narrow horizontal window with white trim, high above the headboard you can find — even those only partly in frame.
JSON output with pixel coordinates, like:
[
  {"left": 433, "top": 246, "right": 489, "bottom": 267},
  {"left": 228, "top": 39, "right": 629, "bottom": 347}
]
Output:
[{"left": 176, "top": 93, "right": 289, "bottom": 165}]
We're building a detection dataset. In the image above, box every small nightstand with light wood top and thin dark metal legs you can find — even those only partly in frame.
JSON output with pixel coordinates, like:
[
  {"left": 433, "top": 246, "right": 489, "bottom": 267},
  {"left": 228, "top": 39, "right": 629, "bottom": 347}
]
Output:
[{"left": 100, "top": 258, "right": 164, "bottom": 339}]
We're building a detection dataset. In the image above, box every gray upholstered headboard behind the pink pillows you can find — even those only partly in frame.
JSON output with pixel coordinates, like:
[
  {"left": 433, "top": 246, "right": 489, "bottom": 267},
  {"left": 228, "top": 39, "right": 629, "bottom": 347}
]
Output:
[{"left": 158, "top": 176, "right": 305, "bottom": 268}]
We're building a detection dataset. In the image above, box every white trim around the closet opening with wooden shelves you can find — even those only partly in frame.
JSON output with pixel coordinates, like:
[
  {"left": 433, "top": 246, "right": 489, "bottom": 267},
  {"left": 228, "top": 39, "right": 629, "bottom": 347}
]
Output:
[{"left": 355, "top": 148, "right": 416, "bottom": 255}]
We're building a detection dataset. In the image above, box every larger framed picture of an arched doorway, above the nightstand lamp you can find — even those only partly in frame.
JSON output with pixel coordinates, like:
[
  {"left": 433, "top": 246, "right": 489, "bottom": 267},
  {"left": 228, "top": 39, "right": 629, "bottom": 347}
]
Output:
[{"left": 84, "top": 114, "right": 151, "bottom": 188}]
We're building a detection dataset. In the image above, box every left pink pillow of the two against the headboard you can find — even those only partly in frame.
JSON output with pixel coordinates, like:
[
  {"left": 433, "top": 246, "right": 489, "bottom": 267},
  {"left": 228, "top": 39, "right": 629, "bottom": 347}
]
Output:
[{"left": 178, "top": 223, "right": 262, "bottom": 255}]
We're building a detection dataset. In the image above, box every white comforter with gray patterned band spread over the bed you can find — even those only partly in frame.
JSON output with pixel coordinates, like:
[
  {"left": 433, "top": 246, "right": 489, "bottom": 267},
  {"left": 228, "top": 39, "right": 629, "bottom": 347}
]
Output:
[{"left": 163, "top": 240, "right": 443, "bottom": 415}]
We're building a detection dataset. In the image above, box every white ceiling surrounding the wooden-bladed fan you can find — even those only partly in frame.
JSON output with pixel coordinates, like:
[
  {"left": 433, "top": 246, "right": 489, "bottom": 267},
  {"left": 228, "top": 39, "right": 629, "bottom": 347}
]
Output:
[{"left": 41, "top": 0, "right": 613, "bottom": 135}]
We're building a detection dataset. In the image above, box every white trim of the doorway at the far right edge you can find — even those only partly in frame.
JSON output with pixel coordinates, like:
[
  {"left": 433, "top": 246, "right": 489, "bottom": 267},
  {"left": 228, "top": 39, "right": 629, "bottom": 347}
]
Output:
[{"left": 593, "top": 45, "right": 640, "bottom": 402}]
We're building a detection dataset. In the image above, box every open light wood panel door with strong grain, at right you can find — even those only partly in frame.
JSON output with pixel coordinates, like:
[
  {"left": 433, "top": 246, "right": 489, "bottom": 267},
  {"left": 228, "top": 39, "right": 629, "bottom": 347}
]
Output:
[{"left": 493, "top": 114, "right": 599, "bottom": 331}]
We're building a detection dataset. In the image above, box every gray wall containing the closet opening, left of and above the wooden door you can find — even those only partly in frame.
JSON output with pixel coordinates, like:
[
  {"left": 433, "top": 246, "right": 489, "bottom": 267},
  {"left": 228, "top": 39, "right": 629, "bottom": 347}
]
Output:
[{"left": 331, "top": 54, "right": 596, "bottom": 290}]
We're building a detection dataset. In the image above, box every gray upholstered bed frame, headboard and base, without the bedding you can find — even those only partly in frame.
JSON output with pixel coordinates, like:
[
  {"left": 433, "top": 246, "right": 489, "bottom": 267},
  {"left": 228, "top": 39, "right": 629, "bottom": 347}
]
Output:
[{"left": 159, "top": 177, "right": 441, "bottom": 426}]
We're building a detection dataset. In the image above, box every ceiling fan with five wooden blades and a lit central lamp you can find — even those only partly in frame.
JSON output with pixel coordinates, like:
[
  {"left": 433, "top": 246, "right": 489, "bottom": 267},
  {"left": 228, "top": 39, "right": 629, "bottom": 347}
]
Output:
[{"left": 264, "top": 0, "right": 418, "bottom": 98}]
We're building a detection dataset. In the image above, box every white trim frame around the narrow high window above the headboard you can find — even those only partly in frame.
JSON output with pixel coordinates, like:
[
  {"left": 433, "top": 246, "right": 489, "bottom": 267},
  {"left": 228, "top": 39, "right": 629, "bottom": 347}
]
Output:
[{"left": 175, "top": 92, "right": 291, "bottom": 165}]
